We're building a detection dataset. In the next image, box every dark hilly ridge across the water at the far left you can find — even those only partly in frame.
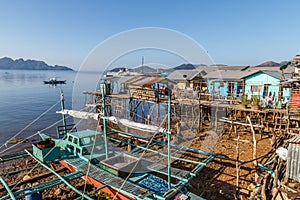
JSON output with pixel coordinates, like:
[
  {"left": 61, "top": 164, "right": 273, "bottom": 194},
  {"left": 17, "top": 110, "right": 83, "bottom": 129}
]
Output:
[{"left": 0, "top": 57, "right": 73, "bottom": 70}]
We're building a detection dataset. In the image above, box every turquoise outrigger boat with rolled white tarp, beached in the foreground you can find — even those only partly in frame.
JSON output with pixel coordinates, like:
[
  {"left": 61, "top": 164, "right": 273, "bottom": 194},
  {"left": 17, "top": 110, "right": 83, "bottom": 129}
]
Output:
[{"left": 0, "top": 84, "right": 239, "bottom": 200}]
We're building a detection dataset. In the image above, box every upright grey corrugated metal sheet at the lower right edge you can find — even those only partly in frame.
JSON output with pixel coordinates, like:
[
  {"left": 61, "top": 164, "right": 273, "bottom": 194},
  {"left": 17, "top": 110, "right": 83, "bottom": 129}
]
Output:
[{"left": 286, "top": 144, "right": 300, "bottom": 182}]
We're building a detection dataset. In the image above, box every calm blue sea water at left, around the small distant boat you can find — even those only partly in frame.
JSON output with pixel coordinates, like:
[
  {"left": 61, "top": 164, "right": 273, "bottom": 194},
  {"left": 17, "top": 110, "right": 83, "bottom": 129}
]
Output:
[{"left": 0, "top": 70, "right": 99, "bottom": 150}]
